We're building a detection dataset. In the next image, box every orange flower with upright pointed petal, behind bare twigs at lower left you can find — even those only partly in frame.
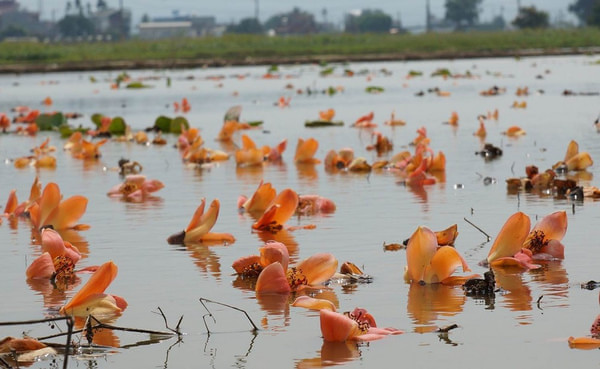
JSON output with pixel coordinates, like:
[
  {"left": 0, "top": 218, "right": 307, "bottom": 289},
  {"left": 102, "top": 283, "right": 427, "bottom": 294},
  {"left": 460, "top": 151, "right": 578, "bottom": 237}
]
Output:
[{"left": 60, "top": 261, "right": 127, "bottom": 317}]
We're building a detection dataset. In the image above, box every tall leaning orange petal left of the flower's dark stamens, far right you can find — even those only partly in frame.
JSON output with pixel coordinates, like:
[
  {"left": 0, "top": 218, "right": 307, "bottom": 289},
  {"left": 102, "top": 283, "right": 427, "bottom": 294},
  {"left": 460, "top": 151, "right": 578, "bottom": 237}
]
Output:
[{"left": 487, "top": 211, "right": 531, "bottom": 264}]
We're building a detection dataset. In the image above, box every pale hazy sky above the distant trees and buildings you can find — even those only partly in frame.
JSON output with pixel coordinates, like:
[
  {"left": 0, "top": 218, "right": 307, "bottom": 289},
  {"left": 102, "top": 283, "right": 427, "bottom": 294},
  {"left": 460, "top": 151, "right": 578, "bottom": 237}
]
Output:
[{"left": 19, "top": 0, "right": 576, "bottom": 27}]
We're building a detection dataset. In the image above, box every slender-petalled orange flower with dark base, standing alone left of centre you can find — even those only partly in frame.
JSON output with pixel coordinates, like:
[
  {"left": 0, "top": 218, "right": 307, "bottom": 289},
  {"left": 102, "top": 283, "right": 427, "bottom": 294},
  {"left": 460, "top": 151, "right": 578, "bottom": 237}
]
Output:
[{"left": 167, "top": 198, "right": 235, "bottom": 245}]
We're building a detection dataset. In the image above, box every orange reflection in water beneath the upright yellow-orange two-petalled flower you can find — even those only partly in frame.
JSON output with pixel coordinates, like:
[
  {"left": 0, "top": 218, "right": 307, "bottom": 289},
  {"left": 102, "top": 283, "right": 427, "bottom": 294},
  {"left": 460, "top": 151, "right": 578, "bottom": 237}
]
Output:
[{"left": 406, "top": 283, "right": 466, "bottom": 333}]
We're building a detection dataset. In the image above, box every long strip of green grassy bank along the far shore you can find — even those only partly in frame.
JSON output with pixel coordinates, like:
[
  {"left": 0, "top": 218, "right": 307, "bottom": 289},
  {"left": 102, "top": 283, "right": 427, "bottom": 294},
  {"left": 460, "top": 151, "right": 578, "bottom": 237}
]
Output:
[{"left": 0, "top": 28, "right": 600, "bottom": 71}]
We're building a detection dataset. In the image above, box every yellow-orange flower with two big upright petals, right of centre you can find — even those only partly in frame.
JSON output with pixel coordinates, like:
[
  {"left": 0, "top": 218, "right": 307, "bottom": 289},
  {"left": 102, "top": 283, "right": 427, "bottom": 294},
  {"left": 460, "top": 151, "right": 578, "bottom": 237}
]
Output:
[{"left": 405, "top": 227, "right": 470, "bottom": 284}]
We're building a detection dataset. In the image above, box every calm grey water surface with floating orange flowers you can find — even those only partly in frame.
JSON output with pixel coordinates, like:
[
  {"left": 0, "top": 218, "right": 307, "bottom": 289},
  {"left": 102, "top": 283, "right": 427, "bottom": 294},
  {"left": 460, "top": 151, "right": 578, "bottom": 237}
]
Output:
[{"left": 0, "top": 57, "right": 600, "bottom": 368}]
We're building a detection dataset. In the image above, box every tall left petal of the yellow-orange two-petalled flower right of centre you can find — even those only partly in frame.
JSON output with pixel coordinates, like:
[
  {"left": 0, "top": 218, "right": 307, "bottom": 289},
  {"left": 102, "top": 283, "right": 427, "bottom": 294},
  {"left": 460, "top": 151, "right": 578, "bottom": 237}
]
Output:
[{"left": 406, "top": 227, "right": 437, "bottom": 282}]
